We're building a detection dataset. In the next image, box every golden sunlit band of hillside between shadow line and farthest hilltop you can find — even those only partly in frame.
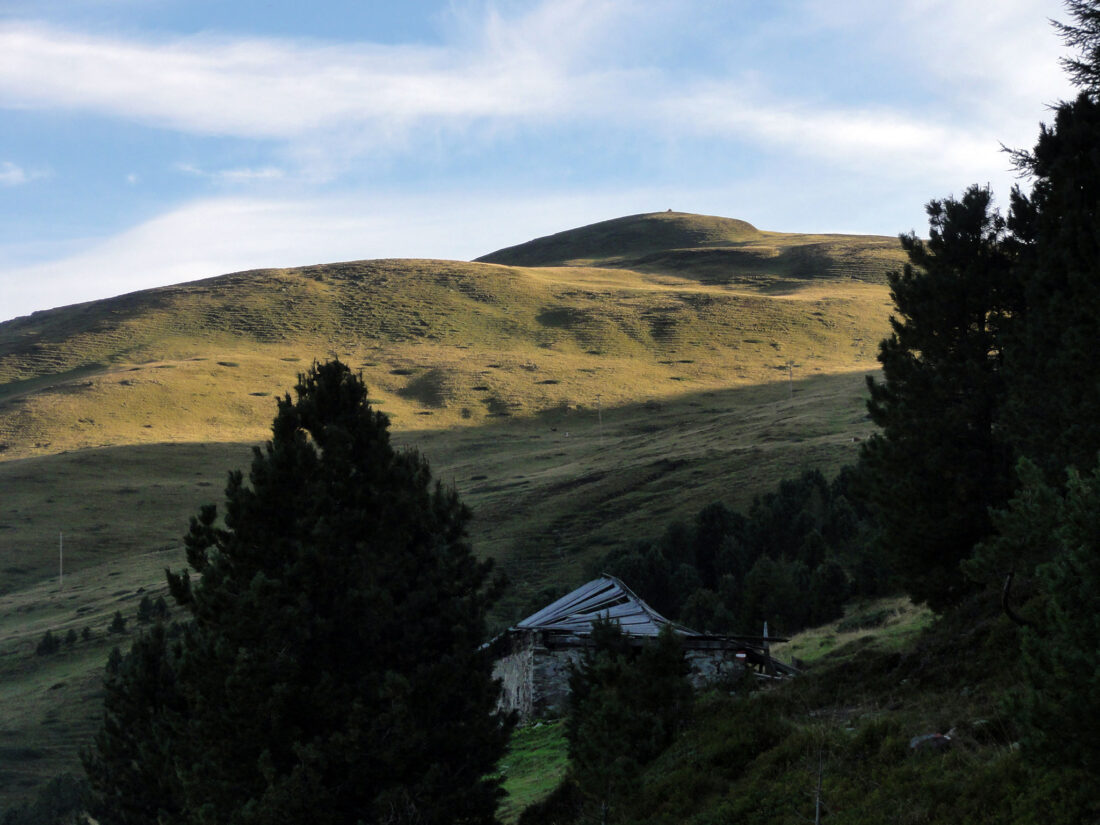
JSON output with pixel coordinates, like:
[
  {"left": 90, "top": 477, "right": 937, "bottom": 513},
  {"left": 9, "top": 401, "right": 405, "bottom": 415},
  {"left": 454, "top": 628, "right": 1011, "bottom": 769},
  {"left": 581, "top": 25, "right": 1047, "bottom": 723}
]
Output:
[{"left": 0, "top": 261, "right": 888, "bottom": 459}]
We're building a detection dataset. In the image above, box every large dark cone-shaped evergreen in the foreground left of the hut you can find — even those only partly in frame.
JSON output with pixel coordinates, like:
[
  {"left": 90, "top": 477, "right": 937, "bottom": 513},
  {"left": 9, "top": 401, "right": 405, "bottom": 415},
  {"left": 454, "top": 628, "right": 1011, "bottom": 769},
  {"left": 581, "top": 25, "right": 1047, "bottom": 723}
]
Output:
[{"left": 85, "top": 361, "right": 510, "bottom": 825}]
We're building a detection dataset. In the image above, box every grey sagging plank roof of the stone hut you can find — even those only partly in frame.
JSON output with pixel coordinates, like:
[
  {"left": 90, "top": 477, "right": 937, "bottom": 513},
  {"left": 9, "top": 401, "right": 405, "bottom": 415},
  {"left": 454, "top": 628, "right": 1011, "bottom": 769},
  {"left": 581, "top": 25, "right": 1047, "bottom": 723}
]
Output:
[{"left": 516, "top": 575, "right": 699, "bottom": 636}]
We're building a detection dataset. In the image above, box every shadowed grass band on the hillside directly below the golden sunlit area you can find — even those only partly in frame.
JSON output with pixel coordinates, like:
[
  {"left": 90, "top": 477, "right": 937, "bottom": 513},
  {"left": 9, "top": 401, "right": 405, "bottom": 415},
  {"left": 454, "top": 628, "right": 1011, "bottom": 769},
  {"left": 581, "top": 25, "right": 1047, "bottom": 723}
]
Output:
[{"left": 0, "top": 374, "right": 870, "bottom": 619}]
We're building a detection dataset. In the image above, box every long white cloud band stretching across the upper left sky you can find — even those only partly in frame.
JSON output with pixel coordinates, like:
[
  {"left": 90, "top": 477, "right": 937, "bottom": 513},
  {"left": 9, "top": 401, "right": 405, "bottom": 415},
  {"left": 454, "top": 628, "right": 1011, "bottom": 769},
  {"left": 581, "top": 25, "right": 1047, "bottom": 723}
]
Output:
[{"left": 0, "top": 11, "right": 585, "bottom": 139}]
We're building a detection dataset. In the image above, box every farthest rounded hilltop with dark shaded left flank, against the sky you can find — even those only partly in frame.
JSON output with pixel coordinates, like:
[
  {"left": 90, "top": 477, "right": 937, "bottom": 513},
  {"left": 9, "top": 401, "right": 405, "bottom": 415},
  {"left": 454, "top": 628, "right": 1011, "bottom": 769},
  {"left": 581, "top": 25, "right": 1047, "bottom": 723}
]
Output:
[{"left": 477, "top": 211, "right": 904, "bottom": 286}]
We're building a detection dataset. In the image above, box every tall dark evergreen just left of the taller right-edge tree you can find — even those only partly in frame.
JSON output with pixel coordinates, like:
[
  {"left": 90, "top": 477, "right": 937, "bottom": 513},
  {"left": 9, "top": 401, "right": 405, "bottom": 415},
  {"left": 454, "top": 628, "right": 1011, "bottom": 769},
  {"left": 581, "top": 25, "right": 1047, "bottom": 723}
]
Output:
[{"left": 861, "top": 186, "right": 1019, "bottom": 609}]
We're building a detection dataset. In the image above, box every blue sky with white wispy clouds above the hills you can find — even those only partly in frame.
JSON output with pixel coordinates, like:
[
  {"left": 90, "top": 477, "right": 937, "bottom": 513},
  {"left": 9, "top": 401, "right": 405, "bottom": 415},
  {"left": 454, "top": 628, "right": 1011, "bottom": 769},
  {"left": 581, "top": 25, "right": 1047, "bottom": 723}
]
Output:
[{"left": 0, "top": 0, "right": 1073, "bottom": 321}]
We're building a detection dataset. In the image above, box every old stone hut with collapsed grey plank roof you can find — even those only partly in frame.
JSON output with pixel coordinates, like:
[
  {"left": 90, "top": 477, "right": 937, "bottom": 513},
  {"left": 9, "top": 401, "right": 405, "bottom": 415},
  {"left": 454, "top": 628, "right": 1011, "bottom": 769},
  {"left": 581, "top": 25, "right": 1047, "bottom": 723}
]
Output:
[{"left": 493, "top": 575, "right": 796, "bottom": 721}]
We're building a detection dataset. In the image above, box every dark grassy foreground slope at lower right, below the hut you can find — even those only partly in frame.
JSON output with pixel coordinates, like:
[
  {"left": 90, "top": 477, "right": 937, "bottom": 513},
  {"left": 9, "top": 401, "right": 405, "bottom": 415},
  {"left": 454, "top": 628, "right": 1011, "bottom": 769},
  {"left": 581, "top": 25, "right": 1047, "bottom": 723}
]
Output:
[{"left": 505, "top": 597, "right": 1100, "bottom": 825}]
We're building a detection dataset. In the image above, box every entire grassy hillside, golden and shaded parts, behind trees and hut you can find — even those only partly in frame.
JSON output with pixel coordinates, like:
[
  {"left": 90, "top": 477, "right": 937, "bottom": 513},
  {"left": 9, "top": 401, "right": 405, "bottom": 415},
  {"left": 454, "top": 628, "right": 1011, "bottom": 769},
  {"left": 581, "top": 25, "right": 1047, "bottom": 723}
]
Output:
[{"left": 0, "top": 213, "right": 900, "bottom": 799}]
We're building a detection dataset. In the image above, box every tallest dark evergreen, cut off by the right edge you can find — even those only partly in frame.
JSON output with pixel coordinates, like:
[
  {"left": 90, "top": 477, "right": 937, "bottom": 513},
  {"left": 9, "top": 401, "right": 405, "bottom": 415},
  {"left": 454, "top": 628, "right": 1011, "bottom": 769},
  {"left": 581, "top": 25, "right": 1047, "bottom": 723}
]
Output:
[{"left": 1007, "top": 94, "right": 1100, "bottom": 483}]
